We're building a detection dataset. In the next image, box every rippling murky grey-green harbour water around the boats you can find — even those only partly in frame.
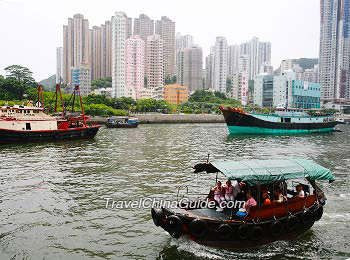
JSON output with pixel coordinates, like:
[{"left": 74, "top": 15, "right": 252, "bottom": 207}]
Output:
[{"left": 0, "top": 124, "right": 350, "bottom": 260}]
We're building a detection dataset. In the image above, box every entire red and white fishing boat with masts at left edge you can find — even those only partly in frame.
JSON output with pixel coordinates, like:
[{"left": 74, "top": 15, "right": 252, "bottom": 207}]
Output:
[{"left": 0, "top": 85, "right": 100, "bottom": 144}]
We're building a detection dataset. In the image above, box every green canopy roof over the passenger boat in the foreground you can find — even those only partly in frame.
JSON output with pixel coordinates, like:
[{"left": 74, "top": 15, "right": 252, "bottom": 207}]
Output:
[{"left": 195, "top": 159, "right": 334, "bottom": 185}]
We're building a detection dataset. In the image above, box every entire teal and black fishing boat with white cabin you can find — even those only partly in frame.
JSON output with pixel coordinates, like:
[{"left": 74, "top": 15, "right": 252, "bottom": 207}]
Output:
[{"left": 220, "top": 107, "right": 339, "bottom": 135}]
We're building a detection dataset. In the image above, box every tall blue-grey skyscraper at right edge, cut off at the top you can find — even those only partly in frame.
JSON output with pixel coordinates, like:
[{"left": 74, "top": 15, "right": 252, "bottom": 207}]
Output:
[{"left": 319, "top": 0, "right": 350, "bottom": 100}]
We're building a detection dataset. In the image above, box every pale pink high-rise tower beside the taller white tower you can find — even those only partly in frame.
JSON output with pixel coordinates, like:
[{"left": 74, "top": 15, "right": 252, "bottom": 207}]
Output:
[{"left": 126, "top": 35, "right": 145, "bottom": 99}]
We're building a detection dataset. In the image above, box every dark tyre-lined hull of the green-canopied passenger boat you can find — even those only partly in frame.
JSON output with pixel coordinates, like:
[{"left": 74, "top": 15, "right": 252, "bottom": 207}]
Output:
[{"left": 152, "top": 195, "right": 323, "bottom": 248}]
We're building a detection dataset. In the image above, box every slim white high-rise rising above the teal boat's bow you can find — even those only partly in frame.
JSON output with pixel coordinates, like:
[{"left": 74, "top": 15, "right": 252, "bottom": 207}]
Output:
[{"left": 214, "top": 37, "right": 227, "bottom": 93}]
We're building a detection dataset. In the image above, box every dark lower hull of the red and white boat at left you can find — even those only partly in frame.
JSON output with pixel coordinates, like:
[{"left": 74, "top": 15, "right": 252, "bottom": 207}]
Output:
[{"left": 0, "top": 126, "right": 100, "bottom": 144}]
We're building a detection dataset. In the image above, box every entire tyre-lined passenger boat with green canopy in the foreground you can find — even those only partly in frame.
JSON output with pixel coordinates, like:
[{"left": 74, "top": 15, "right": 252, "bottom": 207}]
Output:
[{"left": 151, "top": 159, "right": 334, "bottom": 248}]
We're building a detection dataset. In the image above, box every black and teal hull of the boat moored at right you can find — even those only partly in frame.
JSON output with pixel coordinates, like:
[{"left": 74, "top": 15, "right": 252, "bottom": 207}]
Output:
[{"left": 222, "top": 109, "right": 338, "bottom": 135}]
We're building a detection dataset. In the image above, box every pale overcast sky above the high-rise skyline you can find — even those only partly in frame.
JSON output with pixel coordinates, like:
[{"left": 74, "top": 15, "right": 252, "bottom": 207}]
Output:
[{"left": 0, "top": 0, "right": 320, "bottom": 81}]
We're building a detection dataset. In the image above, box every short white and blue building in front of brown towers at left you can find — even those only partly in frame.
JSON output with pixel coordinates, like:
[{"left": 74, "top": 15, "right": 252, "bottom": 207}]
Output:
[{"left": 67, "top": 64, "right": 91, "bottom": 96}]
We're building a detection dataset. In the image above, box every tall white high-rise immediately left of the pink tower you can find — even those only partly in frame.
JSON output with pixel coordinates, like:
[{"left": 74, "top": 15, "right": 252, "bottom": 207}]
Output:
[{"left": 112, "top": 12, "right": 129, "bottom": 97}]
